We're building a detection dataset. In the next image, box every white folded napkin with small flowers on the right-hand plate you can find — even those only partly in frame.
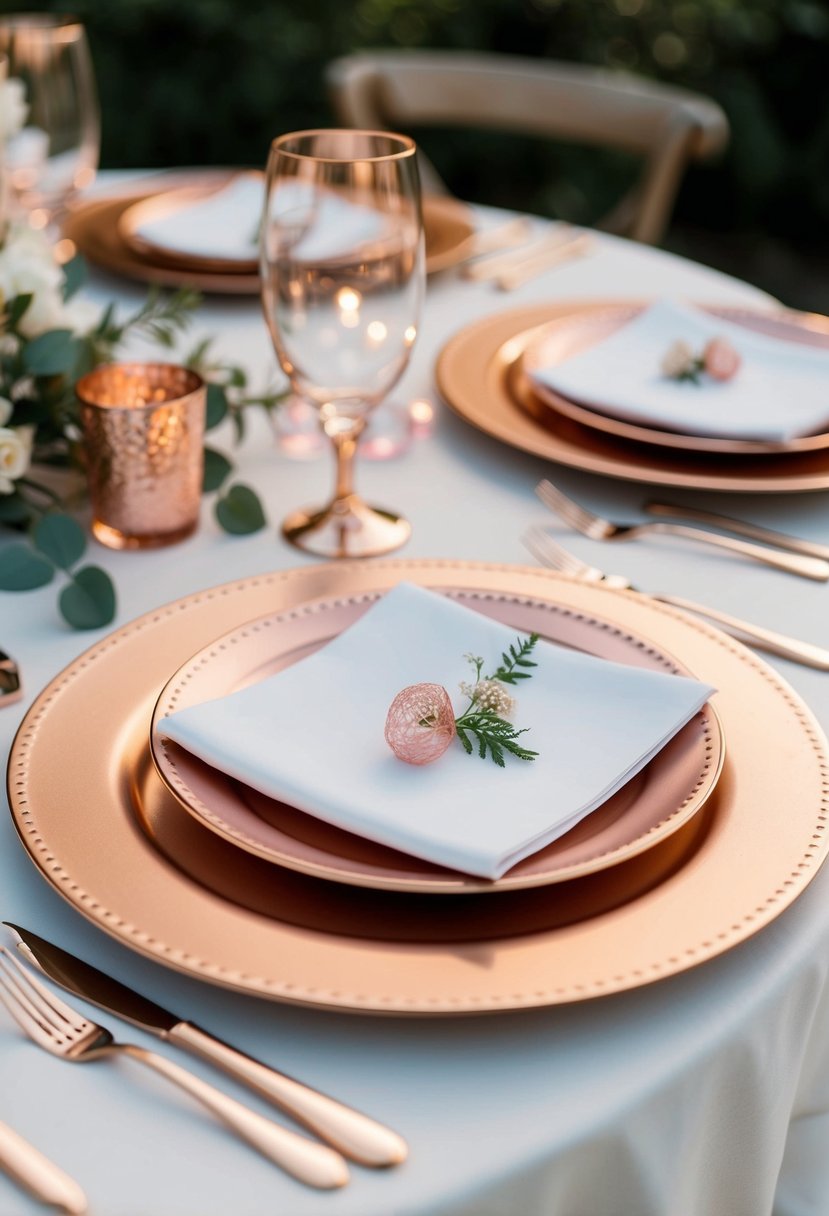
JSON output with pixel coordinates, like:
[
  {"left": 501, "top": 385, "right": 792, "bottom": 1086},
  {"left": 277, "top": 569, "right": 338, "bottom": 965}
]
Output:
[{"left": 525, "top": 300, "right": 829, "bottom": 441}]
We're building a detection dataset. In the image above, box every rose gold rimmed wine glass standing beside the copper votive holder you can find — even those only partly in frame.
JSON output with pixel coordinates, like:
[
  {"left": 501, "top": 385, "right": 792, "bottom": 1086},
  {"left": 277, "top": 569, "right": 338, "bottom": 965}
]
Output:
[{"left": 260, "top": 129, "right": 425, "bottom": 557}]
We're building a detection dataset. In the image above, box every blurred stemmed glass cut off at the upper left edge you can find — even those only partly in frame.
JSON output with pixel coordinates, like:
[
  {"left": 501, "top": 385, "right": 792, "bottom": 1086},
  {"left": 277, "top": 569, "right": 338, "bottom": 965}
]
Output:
[{"left": 0, "top": 12, "right": 101, "bottom": 235}]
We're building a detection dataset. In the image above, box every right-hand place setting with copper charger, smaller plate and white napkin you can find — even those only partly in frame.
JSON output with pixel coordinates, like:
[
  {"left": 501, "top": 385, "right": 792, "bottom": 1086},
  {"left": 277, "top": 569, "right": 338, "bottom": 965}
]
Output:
[{"left": 436, "top": 291, "right": 829, "bottom": 494}]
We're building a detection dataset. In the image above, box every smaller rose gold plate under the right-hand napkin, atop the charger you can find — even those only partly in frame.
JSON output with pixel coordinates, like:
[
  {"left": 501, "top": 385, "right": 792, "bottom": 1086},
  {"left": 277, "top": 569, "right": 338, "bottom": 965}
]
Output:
[{"left": 513, "top": 303, "right": 829, "bottom": 456}]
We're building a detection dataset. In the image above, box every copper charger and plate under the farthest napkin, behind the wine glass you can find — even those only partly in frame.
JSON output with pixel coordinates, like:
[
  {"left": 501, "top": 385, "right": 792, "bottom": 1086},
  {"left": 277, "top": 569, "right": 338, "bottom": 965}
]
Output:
[{"left": 63, "top": 169, "right": 475, "bottom": 295}]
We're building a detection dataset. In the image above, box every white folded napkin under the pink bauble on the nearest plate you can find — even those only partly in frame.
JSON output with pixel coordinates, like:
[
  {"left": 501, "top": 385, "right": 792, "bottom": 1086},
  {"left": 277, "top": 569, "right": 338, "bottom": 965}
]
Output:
[{"left": 159, "top": 584, "right": 714, "bottom": 878}]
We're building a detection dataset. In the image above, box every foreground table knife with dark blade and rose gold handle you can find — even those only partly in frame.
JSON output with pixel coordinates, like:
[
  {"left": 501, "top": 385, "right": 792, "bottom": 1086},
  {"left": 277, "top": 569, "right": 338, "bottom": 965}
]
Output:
[{"left": 4, "top": 921, "right": 408, "bottom": 1166}]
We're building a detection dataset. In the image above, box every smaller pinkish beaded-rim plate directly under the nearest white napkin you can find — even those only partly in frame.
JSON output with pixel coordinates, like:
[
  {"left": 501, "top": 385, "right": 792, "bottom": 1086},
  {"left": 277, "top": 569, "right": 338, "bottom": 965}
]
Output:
[{"left": 150, "top": 592, "right": 724, "bottom": 894}]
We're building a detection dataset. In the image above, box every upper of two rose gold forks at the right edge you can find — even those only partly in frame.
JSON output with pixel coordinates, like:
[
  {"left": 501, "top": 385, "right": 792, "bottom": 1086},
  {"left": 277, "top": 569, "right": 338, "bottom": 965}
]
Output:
[{"left": 536, "top": 480, "right": 829, "bottom": 582}]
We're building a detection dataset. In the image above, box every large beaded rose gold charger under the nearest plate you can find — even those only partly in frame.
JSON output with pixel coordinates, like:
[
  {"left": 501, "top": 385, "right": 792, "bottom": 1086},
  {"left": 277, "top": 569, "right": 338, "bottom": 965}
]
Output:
[{"left": 7, "top": 561, "right": 829, "bottom": 1015}]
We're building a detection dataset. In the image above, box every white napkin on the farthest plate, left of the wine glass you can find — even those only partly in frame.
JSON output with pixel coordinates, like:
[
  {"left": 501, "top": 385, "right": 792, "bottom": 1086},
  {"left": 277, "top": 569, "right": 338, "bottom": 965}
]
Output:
[{"left": 135, "top": 173, "right": 265, "bottom": 261}]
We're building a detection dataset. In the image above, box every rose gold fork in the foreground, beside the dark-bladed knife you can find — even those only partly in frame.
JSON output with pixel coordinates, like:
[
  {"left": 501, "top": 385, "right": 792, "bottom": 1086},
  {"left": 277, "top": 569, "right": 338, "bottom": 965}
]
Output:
[{"left": 0, "top": 946, "right": 349, "bottom": 1189}]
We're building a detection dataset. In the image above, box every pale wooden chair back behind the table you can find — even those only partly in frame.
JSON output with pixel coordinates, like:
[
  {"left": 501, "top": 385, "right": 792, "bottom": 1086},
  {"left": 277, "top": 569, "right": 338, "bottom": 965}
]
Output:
[{"left": 326, "top": 51, "right": 729, "bottom": 244}]
